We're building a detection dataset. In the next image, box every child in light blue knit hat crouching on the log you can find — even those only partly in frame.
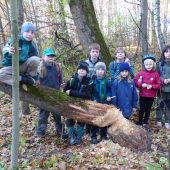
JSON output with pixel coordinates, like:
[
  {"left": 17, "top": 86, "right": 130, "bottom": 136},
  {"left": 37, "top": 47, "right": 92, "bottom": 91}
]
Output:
[{"left": 0, "top": 22, "right": 40, "bottom": 86}]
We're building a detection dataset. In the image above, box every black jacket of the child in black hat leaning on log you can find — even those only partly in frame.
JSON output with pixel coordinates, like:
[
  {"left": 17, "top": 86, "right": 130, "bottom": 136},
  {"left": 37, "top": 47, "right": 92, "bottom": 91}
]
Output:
[{"left": 64, "top": 74, "right": 93, "bottom": 99}]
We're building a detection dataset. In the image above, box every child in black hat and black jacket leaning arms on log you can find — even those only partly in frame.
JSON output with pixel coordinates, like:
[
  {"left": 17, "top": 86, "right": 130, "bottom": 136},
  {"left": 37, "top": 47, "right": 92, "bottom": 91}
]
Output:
[{"left": 64, "top": 61, "right": 93, "bottom": 145}]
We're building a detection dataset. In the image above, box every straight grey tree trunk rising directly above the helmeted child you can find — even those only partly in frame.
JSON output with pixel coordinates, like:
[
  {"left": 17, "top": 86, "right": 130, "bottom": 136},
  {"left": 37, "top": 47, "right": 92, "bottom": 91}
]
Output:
[{"left": 141, "top": 0, "right": 148, "bottom": 56}]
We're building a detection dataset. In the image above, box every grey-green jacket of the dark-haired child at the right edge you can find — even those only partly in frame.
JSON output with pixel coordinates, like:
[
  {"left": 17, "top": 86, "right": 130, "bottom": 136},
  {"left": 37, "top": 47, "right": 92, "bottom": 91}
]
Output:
[{"left": 156, "top": 61, "right": 170, "bottom": 100}]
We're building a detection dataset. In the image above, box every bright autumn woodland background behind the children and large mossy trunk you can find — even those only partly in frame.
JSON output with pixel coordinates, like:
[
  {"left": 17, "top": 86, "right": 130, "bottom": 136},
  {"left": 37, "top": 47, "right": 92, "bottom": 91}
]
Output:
[{"left": 0, "top": 0, "right": 170, "bottom": 79}]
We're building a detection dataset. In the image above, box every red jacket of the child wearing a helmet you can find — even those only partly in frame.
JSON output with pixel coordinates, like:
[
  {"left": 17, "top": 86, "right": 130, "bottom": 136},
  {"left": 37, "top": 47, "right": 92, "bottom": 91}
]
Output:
[{"left": 134, "top": 70, "right": 162, "bottom": 98}]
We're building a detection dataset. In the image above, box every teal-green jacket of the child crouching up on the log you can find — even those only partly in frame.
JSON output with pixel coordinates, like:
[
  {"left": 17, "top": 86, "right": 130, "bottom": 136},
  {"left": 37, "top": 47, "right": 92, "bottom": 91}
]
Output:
[{"left": 1, "top": 35, "right": 38, "bottom": 66}]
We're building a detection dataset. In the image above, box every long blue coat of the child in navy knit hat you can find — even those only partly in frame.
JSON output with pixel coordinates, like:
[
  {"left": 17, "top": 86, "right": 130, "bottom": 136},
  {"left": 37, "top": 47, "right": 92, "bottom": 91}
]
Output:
[{"left": 111, "top": 79, "right": 138, "bottom": 117}]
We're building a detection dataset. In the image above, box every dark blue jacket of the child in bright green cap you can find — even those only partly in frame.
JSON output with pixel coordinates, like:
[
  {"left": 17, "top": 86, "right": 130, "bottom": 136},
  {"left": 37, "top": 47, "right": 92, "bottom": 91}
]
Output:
[{"left": 40, "top": 61, "right": 62, "bottom": 90}]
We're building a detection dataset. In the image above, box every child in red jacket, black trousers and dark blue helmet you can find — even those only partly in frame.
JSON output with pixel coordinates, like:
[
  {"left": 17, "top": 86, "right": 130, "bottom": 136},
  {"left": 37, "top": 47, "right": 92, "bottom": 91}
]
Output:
[{"left": 134, "top": 54, "right": 162, "bottom": 131}]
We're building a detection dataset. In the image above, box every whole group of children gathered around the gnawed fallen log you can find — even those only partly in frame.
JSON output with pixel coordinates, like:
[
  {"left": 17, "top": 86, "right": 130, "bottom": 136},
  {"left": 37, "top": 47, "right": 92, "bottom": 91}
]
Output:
[{"left": 0, "top": 22, "right": 170, "bottom": 145}]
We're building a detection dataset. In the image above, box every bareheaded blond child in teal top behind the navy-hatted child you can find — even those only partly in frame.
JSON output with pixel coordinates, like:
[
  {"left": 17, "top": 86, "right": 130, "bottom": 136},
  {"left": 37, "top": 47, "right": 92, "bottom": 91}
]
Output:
[{"left": 109, "top": 47, "right": 135, "bottom": 82}]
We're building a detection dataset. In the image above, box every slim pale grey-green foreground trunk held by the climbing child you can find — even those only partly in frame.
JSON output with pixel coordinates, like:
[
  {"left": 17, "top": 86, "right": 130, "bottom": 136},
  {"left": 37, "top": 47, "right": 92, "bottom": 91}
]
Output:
[{"left": 10, "top": 0, "right": 19, "bottom": 169}]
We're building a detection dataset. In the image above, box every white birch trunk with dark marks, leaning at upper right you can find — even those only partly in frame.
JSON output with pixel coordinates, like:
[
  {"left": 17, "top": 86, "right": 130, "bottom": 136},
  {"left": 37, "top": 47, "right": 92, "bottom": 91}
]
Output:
[{"left": 153, "top": 0, "right": 165, "bottom": 52}]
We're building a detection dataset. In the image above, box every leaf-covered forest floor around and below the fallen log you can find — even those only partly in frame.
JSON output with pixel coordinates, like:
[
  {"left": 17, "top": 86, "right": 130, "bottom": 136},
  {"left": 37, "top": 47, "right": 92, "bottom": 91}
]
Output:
[{"left": 0, "top": 95, "right": 170, "bottom": 170}]
